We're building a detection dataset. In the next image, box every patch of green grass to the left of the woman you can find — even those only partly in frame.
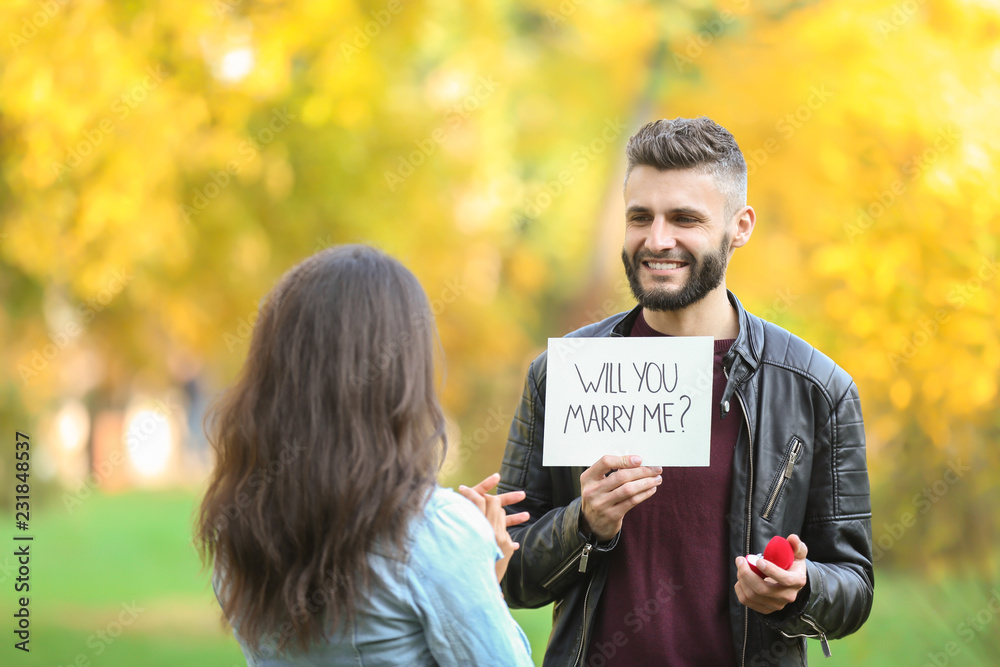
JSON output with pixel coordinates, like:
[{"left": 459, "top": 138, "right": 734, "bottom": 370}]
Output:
[{"left": 0, "top": 492, "right": 246, "bottom": 667}]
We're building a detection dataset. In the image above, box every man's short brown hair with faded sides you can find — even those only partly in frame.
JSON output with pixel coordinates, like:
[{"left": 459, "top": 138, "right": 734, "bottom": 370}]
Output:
[{"left": 625, "top": 116, "right": 747, "bottom": 221}]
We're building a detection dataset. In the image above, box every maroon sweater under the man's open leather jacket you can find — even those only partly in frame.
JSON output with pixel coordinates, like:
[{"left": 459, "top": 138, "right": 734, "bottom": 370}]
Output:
[{"left": 585, "top": 312, "right": 743, "bottom": 667}]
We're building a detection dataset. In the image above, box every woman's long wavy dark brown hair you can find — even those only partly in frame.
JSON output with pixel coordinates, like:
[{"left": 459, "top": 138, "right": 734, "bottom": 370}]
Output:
[{"left": 196, "top": 245, "right": 444, "bottom": 649}]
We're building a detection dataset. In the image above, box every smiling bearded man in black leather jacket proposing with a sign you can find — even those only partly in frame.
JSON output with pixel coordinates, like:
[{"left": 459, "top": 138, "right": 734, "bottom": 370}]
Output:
[{"left": 500, "top": 117, "right": 874, "bottom": 667}]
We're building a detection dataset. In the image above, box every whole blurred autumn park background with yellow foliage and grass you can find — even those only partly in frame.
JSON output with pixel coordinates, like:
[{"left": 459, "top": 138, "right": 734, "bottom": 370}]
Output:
[{"left": 0, "top": 0, "right": 1000, "bottom": 666}]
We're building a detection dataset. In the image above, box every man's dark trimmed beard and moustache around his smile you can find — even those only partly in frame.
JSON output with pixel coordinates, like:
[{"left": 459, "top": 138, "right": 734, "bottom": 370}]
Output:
[{"left": 622, "top": 234, "right": 729, "bottom": 310}]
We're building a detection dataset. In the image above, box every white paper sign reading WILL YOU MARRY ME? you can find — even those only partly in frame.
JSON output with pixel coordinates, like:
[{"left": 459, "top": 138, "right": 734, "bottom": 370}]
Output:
[{"left": 542, "top": 336, "right": 714, "bottom": 467}]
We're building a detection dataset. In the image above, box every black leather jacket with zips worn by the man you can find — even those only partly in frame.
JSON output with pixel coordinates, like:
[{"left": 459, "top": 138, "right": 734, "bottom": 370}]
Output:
[{"left": 499, "top": 293, "right": 874, "bottom": 667}]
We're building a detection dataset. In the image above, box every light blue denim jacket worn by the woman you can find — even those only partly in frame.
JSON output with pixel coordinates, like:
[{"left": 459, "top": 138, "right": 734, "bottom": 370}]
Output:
[{"left": 219, "top": 487, "right": 532, "bottom": 667}]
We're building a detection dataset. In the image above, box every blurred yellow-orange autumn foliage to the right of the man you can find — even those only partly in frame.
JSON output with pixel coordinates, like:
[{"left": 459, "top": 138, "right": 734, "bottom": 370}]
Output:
[{"left": 661, "top": 0, "right": 1000, "bottom": 571}]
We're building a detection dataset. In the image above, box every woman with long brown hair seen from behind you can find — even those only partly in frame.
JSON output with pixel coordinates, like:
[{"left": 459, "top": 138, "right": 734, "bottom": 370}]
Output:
[{"left": 197, "top": 246, "right": 531, "bottom": 666}]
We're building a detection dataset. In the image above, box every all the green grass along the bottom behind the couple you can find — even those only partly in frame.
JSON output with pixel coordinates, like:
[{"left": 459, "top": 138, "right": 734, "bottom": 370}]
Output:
[{"left": 0, "top": 491, "right": 1000, "bottom": 667}]
